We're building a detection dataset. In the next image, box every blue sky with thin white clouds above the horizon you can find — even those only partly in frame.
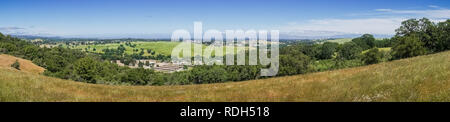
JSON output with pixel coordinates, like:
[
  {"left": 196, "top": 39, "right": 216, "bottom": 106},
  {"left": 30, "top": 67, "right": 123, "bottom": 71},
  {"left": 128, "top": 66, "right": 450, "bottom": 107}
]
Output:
[{"left": 0, "top": 0, "right": 450, "bottom": 38}]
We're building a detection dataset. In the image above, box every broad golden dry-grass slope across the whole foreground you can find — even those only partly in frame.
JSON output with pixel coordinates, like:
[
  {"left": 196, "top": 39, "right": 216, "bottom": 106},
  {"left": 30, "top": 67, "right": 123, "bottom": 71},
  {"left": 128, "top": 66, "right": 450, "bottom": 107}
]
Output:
[{"left": 0, "top": 52, "right": 450, "bottom": 101}]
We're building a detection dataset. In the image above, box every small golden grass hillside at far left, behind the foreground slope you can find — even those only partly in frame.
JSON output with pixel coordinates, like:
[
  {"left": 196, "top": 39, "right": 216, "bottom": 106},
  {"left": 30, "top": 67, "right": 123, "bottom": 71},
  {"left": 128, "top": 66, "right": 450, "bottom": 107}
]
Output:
[{"left": 0, "top": 54, "right": 45, "bottom": 74}]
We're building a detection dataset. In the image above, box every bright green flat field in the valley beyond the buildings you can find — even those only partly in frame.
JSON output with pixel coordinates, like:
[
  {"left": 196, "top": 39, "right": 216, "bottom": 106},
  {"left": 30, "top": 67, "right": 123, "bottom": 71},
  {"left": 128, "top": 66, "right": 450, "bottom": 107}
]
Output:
[{"left": 69, "top": 41, "right": 248, "bottom": 56}]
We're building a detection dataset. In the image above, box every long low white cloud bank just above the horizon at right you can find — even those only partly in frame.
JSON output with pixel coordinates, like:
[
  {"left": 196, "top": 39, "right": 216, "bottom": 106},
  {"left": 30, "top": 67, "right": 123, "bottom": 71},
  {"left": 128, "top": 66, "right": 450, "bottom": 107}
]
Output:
[{"left": 280, "top": 18, "right": 406, "bottom": 37}]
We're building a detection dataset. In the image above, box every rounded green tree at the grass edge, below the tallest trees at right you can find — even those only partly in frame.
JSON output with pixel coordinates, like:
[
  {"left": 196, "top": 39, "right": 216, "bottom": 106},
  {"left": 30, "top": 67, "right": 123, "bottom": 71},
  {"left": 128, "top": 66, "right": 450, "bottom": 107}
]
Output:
[{"left": 392, "top": 35, "right": 426, "bottom": 59}]
